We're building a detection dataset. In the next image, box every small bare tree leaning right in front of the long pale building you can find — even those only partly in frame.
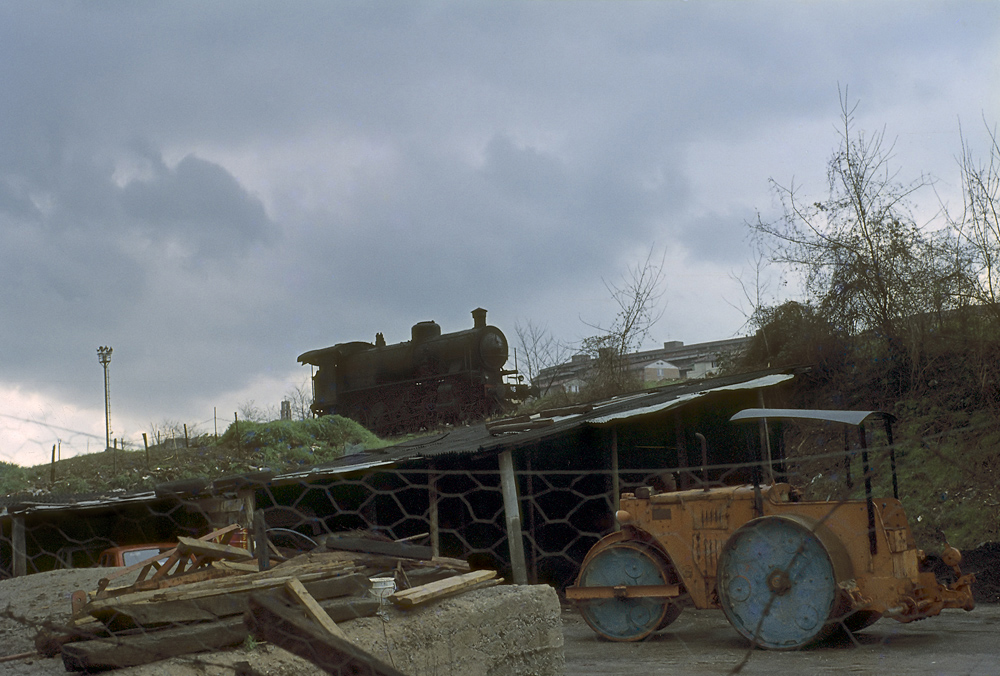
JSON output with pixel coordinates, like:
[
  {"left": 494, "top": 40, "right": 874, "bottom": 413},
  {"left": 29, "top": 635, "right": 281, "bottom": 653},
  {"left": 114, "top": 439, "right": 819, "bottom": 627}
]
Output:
[{"left": 582, "top": 246, "right": 666, "bottom": 396}]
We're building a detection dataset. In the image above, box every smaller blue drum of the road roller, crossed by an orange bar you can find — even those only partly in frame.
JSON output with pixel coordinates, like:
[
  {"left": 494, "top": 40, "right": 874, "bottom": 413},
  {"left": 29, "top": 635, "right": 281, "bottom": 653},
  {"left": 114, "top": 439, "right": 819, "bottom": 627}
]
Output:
[{"left": 577, "top": 542, "right": 681, "bottom": 641}]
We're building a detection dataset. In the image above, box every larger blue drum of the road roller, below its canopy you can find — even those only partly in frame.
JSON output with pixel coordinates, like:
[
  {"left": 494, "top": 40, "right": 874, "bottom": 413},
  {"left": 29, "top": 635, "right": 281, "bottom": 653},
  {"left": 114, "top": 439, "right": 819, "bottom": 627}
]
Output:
[{"left": 717, "top": 516, "right": 849, "bottom": 650}]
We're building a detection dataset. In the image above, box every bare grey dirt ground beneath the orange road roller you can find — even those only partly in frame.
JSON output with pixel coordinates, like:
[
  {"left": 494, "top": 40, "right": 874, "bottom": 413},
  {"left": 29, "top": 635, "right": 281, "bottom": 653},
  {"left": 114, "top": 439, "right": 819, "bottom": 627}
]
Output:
[{"left": 563, "top": 604, "right": 1000, "bottom": 676}]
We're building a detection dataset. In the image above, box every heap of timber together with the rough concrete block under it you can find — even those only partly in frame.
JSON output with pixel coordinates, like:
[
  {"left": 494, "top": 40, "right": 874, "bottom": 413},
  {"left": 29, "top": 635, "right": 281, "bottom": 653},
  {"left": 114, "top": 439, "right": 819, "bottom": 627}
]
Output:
[{"left": 36, "top": 529, "right": 563, "bottom": 676}]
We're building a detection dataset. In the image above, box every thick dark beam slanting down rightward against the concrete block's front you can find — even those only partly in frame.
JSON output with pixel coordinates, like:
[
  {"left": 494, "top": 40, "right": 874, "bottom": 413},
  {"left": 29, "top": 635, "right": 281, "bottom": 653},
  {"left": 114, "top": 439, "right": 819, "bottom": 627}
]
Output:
[{"left": 246, "top": 594, "right": 405, "bottom": 676}]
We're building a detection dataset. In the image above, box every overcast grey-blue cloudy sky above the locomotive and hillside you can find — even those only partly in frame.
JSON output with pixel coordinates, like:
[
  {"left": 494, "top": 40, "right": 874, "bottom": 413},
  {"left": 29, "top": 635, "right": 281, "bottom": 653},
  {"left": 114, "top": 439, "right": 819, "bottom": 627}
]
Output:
[{"left": 0, "top": 0, "right": 1000, "bottom": 464}]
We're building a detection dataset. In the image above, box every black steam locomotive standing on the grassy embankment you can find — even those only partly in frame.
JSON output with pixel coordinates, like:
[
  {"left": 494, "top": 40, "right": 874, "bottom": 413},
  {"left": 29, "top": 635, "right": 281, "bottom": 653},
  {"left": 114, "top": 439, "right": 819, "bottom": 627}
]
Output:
[{"left": 298, "top": 308, "right": 528, "bottom": 436}]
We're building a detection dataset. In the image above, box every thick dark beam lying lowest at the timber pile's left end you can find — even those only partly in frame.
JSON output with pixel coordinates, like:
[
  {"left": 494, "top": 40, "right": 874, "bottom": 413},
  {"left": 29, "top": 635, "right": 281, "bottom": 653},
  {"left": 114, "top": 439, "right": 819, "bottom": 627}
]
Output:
[{"left": 62, "top": 616, "right": 249, "bottom": 671}]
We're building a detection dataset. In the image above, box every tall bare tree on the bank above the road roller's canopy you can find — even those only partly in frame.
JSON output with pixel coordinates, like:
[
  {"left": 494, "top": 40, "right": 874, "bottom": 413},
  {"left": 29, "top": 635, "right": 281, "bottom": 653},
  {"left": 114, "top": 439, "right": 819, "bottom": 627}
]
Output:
[{"left": 750, "top": 91, "right": 961, "bottom": 394}]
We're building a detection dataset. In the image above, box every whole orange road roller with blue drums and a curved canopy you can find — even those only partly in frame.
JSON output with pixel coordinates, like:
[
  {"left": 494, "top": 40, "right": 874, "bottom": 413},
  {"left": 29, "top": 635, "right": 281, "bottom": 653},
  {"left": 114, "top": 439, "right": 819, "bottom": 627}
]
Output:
[{"left": 566, "top": 409, "right": 975, "bottom": 650}]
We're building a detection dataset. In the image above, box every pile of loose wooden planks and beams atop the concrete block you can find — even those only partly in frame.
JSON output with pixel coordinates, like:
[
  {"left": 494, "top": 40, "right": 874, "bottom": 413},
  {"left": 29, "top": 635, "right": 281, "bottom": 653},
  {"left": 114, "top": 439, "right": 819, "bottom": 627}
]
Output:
[{"left": 43, "top": 534, "right": 498, "bottom": 674}]
